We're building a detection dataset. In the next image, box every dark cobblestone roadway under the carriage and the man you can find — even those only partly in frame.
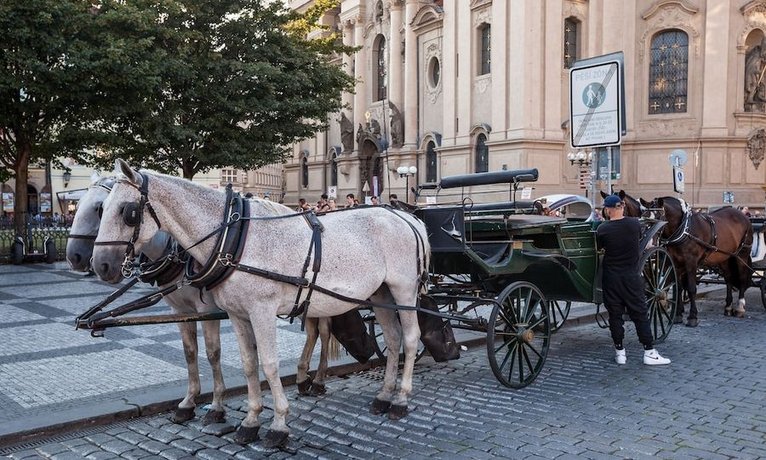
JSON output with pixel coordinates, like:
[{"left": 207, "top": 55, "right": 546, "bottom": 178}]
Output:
[{"left": 0, "top": 278, "right": 766, "bottom": 459}]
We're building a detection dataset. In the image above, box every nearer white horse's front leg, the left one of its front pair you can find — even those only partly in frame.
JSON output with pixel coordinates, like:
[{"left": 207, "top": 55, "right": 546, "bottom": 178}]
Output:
[{"left": 230, "top": 316, "right": 263, "bottom": 444}]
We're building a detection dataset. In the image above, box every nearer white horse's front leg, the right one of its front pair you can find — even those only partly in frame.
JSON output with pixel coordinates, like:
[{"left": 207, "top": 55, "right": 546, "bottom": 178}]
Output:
[{"left": 250, "top": 310, "right": 290, "bottom": 448}]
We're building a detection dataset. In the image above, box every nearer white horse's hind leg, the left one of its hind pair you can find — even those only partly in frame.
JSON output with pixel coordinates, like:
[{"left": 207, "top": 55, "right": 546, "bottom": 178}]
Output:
[{"left": 370, "top": 306, "right": 401, "bottom": 415}]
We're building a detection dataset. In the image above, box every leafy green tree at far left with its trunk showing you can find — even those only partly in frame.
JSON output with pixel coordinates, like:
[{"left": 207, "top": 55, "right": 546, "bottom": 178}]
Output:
[{"left": 0, "top": 0, "right": 169, "bottom": 235}]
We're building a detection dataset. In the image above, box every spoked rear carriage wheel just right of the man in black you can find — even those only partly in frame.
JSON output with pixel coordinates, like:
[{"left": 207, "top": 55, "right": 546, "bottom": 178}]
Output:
[{"left": 639, "top": 246, "right": 681, "bottom": 342}]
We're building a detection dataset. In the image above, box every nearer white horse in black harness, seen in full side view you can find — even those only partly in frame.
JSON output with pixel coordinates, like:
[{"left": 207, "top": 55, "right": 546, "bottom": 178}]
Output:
[{"left": 93, "top": 160, "right": 430, "bottom": 447}]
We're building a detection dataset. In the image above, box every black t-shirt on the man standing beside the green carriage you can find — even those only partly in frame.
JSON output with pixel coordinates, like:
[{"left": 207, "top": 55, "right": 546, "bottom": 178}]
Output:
[{"left": 596, "top": 217, "right": 641, "bottom": 274}]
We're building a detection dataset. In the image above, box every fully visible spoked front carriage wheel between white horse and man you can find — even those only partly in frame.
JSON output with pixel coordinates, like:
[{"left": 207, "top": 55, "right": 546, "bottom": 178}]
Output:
[{"left": 487, "top": 281, "right": 551, "bottom": 388}]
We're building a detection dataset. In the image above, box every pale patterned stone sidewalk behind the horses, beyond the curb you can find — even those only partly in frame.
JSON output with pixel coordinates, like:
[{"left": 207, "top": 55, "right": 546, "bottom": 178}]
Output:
[{"left": 0, "top": 262, "right": 721, "bottom": 446}]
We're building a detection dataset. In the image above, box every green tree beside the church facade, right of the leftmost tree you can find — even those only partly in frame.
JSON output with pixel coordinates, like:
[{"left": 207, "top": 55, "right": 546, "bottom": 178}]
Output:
[{"left": 80, "top": 0, "right": 353, "bottom": 178}]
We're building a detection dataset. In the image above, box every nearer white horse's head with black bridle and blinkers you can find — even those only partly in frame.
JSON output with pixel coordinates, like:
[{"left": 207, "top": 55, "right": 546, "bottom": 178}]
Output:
[{"left": 93, "top": 159, "right": 165, "bottom": 283}]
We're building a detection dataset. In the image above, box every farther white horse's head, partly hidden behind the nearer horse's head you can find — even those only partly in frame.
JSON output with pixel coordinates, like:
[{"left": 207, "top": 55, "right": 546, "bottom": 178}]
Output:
[{"left": 66, "top": 176, "right": 115, "bottom": 272}]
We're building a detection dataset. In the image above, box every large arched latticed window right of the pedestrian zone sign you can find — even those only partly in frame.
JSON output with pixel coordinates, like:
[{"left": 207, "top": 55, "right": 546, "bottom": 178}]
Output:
[{"left": 648, "top": 29, "right": 689, "bottom": 114}]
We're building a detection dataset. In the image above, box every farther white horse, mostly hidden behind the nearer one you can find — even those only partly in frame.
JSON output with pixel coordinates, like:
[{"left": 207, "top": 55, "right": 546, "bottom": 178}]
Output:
[{"left": 66, "top": 177, "right": 338, "bottom": 425}]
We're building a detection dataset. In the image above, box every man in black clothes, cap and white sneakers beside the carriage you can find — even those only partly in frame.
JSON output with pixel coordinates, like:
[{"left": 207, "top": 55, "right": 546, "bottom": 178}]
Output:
[{"left": 596, "top": 195, "right": 670, "bottom": 365}]
